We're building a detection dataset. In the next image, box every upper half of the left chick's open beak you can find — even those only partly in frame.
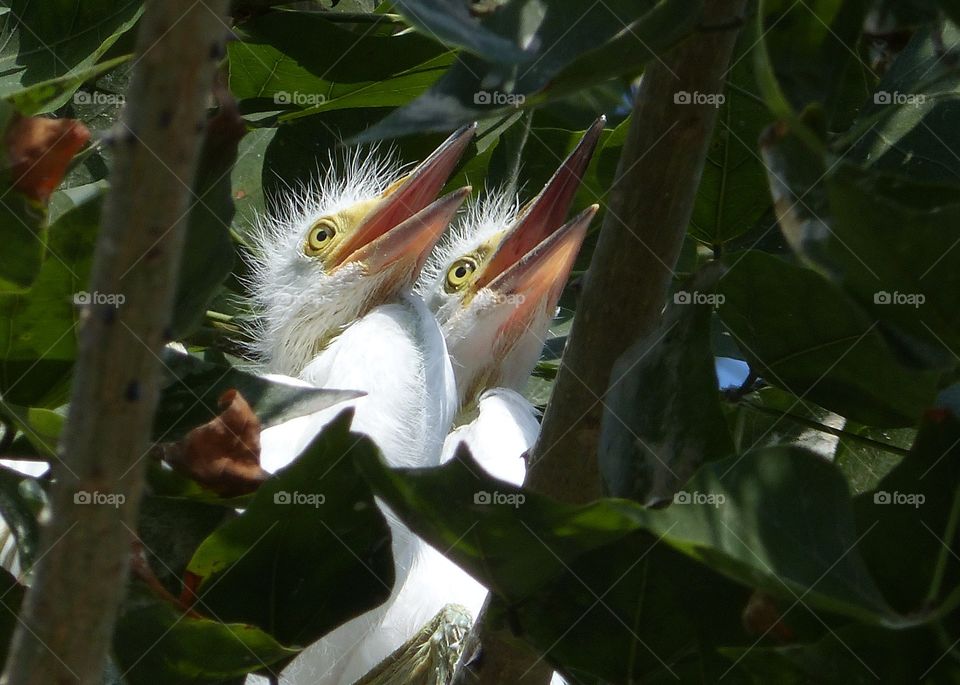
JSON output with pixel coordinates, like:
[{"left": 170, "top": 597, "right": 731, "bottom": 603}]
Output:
[{"left": 330, "top": 124, "right": 477, "bottom": 267}]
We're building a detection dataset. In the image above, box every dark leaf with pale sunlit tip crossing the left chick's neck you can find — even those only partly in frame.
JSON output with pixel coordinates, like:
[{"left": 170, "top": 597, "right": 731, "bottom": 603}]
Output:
[{"left": 153, "top": 351, "right": 360, "bottom": 441}]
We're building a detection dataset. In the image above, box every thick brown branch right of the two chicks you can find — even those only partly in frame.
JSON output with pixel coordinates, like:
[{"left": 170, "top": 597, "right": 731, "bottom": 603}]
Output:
[{"left": 454, "top": 0, "right": 746, "bottom": 685}]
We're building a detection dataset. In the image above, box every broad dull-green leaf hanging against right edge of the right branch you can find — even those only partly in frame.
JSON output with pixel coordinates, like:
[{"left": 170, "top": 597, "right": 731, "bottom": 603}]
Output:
[{"left": 598, "top": 270, "right": 733, "bottom": 504}]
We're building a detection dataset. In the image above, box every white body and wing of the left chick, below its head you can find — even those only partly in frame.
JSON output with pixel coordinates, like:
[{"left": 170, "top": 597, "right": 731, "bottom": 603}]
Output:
[{"left": 264, "top": 296, "right": 456, "bottom": 685}]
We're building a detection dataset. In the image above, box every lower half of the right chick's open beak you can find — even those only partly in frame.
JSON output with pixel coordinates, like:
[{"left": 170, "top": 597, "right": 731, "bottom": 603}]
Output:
[{"left": 487, "top": 205, "right": 599, "bottom": 310}]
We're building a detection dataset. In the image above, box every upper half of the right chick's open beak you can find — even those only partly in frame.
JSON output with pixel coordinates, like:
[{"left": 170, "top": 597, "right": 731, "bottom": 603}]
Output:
[{"left": 473, "top": 117, "right": 606, "bottom": 291}]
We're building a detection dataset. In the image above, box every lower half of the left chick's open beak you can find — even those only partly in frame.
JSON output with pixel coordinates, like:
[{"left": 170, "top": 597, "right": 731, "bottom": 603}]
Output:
[{"left": 351, "top": 186, "right": 471, "bottom": 276}]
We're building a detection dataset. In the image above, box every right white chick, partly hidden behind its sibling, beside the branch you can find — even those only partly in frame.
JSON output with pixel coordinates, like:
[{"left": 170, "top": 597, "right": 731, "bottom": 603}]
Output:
[{"left": 358, "top": 119, "right": 604, "bottom": 683}]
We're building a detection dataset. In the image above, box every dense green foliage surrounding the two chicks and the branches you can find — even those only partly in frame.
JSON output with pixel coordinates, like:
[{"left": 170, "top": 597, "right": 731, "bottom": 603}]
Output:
[{"left": 0, "top": 0, "right": 960, "bottom": 683}]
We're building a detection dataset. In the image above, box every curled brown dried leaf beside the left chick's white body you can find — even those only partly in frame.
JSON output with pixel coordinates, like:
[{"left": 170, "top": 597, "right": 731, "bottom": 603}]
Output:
[{"left": 164, "top": 389, "right": 269, "bottom": 497}]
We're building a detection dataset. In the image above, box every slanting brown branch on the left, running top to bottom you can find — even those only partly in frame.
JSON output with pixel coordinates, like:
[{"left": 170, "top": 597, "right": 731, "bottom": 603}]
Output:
[{"left": 0, "top": 0, "right": 228, "bottom": 685}]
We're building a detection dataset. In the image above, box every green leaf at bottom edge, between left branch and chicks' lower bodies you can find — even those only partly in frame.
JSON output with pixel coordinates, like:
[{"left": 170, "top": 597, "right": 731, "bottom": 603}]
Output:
[{"left": 113, "top": 584, "right": 298, "bottom": 685}]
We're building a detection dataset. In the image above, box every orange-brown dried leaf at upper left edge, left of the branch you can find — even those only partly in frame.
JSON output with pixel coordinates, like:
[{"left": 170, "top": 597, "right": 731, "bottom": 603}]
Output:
[{"left": 5, "top": 115, "right": 90, "bottom": 202}]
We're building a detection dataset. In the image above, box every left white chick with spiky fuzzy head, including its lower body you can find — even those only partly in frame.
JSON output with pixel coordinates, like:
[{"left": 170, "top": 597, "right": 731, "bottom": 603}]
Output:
[{"left": 242, "top": 126, "right": 475, "bottom": 685}]
